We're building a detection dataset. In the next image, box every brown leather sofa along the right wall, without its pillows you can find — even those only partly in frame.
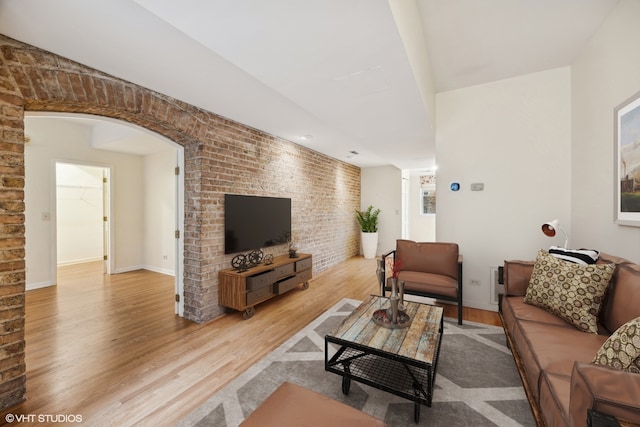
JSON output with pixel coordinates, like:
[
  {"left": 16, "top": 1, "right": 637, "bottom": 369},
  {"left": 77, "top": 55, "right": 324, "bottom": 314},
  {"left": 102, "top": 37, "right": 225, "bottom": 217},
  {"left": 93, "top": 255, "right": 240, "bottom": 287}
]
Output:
[{"left": 499, "top": 254, "right": 640, "bottom": 426}]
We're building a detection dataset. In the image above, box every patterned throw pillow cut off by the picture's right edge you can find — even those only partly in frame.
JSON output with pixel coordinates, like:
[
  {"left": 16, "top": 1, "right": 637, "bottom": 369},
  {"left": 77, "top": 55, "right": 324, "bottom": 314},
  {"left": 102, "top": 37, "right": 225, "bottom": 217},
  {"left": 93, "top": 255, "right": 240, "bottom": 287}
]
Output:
[{"left": 593, "top": 317, "right": 640, "bottom": 374}]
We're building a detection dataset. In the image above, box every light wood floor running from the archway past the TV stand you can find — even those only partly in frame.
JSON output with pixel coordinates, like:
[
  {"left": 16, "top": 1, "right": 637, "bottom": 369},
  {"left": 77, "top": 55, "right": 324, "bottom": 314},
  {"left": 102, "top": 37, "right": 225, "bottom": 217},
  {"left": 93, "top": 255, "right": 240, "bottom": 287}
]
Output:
[{"left": 0, "top": 257, "right": 500, "bottom": 426}]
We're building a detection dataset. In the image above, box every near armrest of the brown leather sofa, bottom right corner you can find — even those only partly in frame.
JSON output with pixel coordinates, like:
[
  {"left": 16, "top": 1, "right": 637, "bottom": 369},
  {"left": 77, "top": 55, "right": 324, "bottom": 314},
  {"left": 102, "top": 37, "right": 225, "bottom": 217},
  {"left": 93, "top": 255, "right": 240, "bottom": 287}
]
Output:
[{"left": 569, "top": 362, "right": 640, "bottom": 426}]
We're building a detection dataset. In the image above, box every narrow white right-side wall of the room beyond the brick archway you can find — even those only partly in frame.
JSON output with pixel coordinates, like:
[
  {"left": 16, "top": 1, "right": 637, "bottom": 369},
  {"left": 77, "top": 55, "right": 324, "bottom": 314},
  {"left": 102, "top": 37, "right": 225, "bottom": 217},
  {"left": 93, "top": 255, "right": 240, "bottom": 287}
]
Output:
[{"left": 143, "top": 148, "right": 178, "bottom": 275}]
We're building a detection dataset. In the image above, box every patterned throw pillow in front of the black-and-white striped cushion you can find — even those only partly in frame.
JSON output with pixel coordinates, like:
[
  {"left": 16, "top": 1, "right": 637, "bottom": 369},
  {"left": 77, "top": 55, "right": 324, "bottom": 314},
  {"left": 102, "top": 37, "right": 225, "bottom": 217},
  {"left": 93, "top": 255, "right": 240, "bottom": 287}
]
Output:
[{"left": 524, "top": 249, "right": 615, "bottom": 334}]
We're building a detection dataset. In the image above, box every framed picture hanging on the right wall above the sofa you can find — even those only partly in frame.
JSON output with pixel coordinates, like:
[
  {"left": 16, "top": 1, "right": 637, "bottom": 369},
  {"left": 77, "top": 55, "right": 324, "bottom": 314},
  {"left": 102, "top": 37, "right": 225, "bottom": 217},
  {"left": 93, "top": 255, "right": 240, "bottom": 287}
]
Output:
[{"left": 614, "top": 92, "right": 640, "bottom": 227}]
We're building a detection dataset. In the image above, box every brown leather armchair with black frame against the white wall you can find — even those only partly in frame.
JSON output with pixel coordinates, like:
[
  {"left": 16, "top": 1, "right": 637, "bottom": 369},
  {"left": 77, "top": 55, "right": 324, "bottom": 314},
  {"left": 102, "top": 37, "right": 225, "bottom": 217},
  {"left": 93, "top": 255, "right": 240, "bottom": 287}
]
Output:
[{"left": 380, "top": 240, "right": 462, "bottom": 325}]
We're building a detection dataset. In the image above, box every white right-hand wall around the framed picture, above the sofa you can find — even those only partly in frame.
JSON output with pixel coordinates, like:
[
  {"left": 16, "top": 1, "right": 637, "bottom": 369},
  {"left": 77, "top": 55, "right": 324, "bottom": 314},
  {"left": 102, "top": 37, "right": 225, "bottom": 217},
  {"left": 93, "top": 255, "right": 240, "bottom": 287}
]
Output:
[{"left": 571, "top": 0, "right": 640, "bottom": 262}]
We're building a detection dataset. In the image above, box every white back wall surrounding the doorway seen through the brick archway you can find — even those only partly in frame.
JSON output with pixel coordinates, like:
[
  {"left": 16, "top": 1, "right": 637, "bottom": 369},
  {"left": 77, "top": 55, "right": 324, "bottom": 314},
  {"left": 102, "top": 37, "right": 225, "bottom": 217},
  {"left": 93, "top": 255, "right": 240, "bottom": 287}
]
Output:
[{"left": 25, "top": 117, "right": 164, "bottom": 289}]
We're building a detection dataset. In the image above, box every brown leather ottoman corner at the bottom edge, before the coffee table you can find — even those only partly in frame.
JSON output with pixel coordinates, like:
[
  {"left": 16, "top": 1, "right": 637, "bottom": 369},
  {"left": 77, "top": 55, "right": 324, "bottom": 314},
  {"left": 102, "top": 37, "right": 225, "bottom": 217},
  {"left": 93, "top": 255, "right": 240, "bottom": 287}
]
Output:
[{"left": 240, "top": 382, "right": 385, "bottom": 427}]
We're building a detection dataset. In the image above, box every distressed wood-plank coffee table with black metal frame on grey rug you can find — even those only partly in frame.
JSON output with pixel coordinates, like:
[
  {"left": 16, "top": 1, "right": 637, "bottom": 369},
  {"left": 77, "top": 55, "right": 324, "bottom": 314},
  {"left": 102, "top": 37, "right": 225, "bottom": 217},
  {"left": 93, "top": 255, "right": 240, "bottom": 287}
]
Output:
[{"left": 324, "top": 295, "right": 443, "bottom": 423}]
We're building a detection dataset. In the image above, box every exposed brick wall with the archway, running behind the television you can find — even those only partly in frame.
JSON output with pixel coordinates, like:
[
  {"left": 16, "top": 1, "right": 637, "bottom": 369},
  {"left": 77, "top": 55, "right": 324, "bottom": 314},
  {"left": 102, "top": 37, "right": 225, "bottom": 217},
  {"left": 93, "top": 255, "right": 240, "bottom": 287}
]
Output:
[{"left": 0, "top": 35, "right": 360, "bottom": 408}]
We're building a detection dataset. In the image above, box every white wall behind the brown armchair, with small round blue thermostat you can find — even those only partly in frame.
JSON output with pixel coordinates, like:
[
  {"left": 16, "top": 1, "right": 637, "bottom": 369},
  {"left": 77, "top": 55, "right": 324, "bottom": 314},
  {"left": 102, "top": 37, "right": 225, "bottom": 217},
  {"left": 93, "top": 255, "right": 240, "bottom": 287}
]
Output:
[{"left": 436, "top": 67, "right": 571, "bottom": 310}]
